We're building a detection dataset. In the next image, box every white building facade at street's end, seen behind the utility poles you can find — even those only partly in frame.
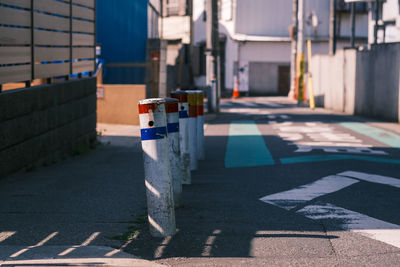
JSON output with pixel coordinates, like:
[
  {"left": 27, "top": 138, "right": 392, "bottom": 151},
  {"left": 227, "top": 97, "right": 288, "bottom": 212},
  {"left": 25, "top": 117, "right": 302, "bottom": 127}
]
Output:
[{"left": 193, "top": 0, "right": 368, "bottom": 95}]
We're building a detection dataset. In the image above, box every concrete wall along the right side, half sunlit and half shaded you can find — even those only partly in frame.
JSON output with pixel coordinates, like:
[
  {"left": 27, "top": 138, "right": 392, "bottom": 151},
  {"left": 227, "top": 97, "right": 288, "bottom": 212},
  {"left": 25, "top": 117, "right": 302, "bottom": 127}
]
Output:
[{"left": 311, "top": 43, "right": 400, "bottom": 122}]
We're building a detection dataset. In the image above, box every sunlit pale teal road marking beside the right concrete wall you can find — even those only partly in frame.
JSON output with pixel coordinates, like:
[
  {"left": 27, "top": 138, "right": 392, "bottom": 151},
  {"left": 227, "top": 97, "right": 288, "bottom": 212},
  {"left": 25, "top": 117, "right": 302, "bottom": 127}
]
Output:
[{"left": 340, "top": 122, "right": 400, "bottom": 148}]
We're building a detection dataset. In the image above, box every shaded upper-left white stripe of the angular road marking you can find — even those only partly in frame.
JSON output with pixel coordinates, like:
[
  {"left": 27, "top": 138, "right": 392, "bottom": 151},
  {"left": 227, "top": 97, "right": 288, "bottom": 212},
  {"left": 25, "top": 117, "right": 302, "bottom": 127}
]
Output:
[{"left": 260, "top": 175, "right": 359, "bottom": 210}]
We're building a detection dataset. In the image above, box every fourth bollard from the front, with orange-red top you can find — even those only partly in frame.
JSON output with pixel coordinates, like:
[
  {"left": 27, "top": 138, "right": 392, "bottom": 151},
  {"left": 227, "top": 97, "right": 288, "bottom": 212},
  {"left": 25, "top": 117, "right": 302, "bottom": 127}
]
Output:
[{"left": 186, "top": 90, "right": 198, "bottom": 171}]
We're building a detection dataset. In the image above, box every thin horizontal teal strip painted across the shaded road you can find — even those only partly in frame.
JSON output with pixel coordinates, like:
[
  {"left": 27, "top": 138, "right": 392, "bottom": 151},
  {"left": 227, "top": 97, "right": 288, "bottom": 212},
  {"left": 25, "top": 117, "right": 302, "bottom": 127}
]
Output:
[{"left": 280, "top": 155, "right": 400, "bottom": 164}]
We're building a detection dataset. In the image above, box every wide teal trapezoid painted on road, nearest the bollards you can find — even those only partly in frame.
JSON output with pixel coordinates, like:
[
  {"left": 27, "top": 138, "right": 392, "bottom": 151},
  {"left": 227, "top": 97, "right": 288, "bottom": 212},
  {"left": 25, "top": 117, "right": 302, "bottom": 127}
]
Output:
[{"left": 225, "top": 121, "right": 275, "bottom": 168}]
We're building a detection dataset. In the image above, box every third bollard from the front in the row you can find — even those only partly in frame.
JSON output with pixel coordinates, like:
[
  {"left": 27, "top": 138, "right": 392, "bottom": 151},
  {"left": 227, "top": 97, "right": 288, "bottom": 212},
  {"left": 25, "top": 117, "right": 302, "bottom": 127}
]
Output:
[{"left": 171, "top": 91, "right": 192, "bottom": 184}]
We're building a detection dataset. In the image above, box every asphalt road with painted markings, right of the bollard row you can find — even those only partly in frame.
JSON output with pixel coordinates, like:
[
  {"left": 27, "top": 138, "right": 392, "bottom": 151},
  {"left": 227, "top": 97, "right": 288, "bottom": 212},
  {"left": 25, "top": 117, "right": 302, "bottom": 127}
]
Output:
[{"left": 125, "top": 98, "right": 400, "bottom": 266}]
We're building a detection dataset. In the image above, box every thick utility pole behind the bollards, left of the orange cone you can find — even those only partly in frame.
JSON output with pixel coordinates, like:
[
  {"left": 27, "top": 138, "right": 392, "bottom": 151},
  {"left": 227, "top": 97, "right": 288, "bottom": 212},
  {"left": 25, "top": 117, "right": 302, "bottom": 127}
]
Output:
[{"left": 206, "top": 0, "right": 219, "bottom": 113}]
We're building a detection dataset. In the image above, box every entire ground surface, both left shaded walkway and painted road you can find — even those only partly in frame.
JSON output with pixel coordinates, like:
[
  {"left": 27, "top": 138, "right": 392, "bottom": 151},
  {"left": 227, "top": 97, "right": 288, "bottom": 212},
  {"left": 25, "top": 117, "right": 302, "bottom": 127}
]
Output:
[{"left": 0, "top": 98, "right": 400, "bottom": 266}]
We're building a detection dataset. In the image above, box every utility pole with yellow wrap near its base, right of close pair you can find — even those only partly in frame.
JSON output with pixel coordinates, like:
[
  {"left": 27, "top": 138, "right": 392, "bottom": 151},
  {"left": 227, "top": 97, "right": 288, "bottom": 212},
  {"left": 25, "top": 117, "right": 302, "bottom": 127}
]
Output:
[{"left": 296, "top": 0, "right": 305, "bottom": 104}]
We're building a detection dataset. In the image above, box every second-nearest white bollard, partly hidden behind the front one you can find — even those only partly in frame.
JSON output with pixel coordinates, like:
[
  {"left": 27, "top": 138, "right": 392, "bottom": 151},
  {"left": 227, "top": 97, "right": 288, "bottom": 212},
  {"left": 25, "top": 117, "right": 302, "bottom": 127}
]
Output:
[{"left": 165, "top": 98, "right": 183, "bottom": 207}]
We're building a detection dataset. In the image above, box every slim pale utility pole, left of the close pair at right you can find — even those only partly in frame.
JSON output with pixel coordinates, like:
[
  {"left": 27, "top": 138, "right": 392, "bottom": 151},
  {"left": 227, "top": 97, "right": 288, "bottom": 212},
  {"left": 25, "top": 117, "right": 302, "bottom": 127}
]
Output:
[{"left": 288, "top": 0, "right": 298, "bottom": 98}]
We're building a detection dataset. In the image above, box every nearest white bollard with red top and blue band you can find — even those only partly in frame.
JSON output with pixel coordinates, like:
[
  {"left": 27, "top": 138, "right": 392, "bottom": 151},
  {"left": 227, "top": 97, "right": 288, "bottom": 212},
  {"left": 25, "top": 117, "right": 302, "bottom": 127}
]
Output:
[{"left": 139, "top": 98, "right": 176, "bottom": 237}]
